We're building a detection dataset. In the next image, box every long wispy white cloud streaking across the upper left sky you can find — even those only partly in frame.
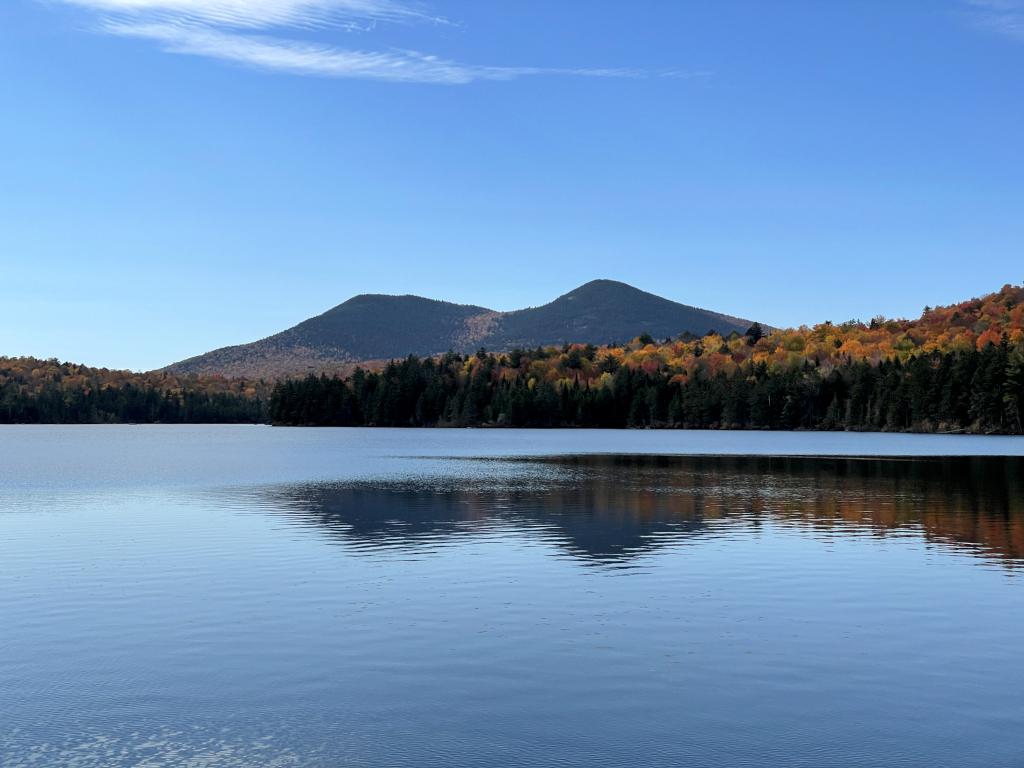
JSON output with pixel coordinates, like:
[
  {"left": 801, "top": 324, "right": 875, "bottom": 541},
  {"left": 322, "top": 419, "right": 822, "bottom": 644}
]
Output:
[{"left": 48, "top": 0, "right": 675, "bottom": 85}]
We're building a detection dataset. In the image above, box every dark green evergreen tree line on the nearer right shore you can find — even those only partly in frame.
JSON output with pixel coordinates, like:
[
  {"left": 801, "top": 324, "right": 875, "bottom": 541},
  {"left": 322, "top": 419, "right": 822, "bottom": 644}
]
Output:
[{"left": 269, "top": 338, "right": 1024, "bottom": 434}]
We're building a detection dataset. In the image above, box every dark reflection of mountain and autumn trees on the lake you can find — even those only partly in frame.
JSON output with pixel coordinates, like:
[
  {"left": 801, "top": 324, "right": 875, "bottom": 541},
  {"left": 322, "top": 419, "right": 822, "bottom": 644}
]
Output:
[{"left": 250, "top": 456, "right": 1024, "bottom": 568}]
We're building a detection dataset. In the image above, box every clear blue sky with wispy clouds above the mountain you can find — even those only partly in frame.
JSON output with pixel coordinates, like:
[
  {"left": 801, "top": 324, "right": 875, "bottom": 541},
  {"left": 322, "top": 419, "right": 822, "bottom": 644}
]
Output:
[{"left": 0, "top": 0, "right": 1024, "bottom": 369}]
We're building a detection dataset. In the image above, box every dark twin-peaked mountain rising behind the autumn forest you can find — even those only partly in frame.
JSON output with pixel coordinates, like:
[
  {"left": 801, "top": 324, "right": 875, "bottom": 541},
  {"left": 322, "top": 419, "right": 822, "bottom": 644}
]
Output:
[{"left": 165, "top": 280, "right": 752, "bottom": 377}]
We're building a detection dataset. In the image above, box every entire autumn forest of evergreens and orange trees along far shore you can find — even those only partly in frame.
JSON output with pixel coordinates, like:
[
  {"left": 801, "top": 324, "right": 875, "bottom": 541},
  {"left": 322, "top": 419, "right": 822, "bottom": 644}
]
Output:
[{"left": 6, "top": 286, "right": 1024, "bottom": 434}]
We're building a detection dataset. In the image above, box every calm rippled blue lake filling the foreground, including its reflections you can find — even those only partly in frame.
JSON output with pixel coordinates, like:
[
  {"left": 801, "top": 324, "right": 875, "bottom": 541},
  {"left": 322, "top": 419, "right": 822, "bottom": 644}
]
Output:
[{"left": 0, "top": 426, "right": 1024, "bottom": 768}]
